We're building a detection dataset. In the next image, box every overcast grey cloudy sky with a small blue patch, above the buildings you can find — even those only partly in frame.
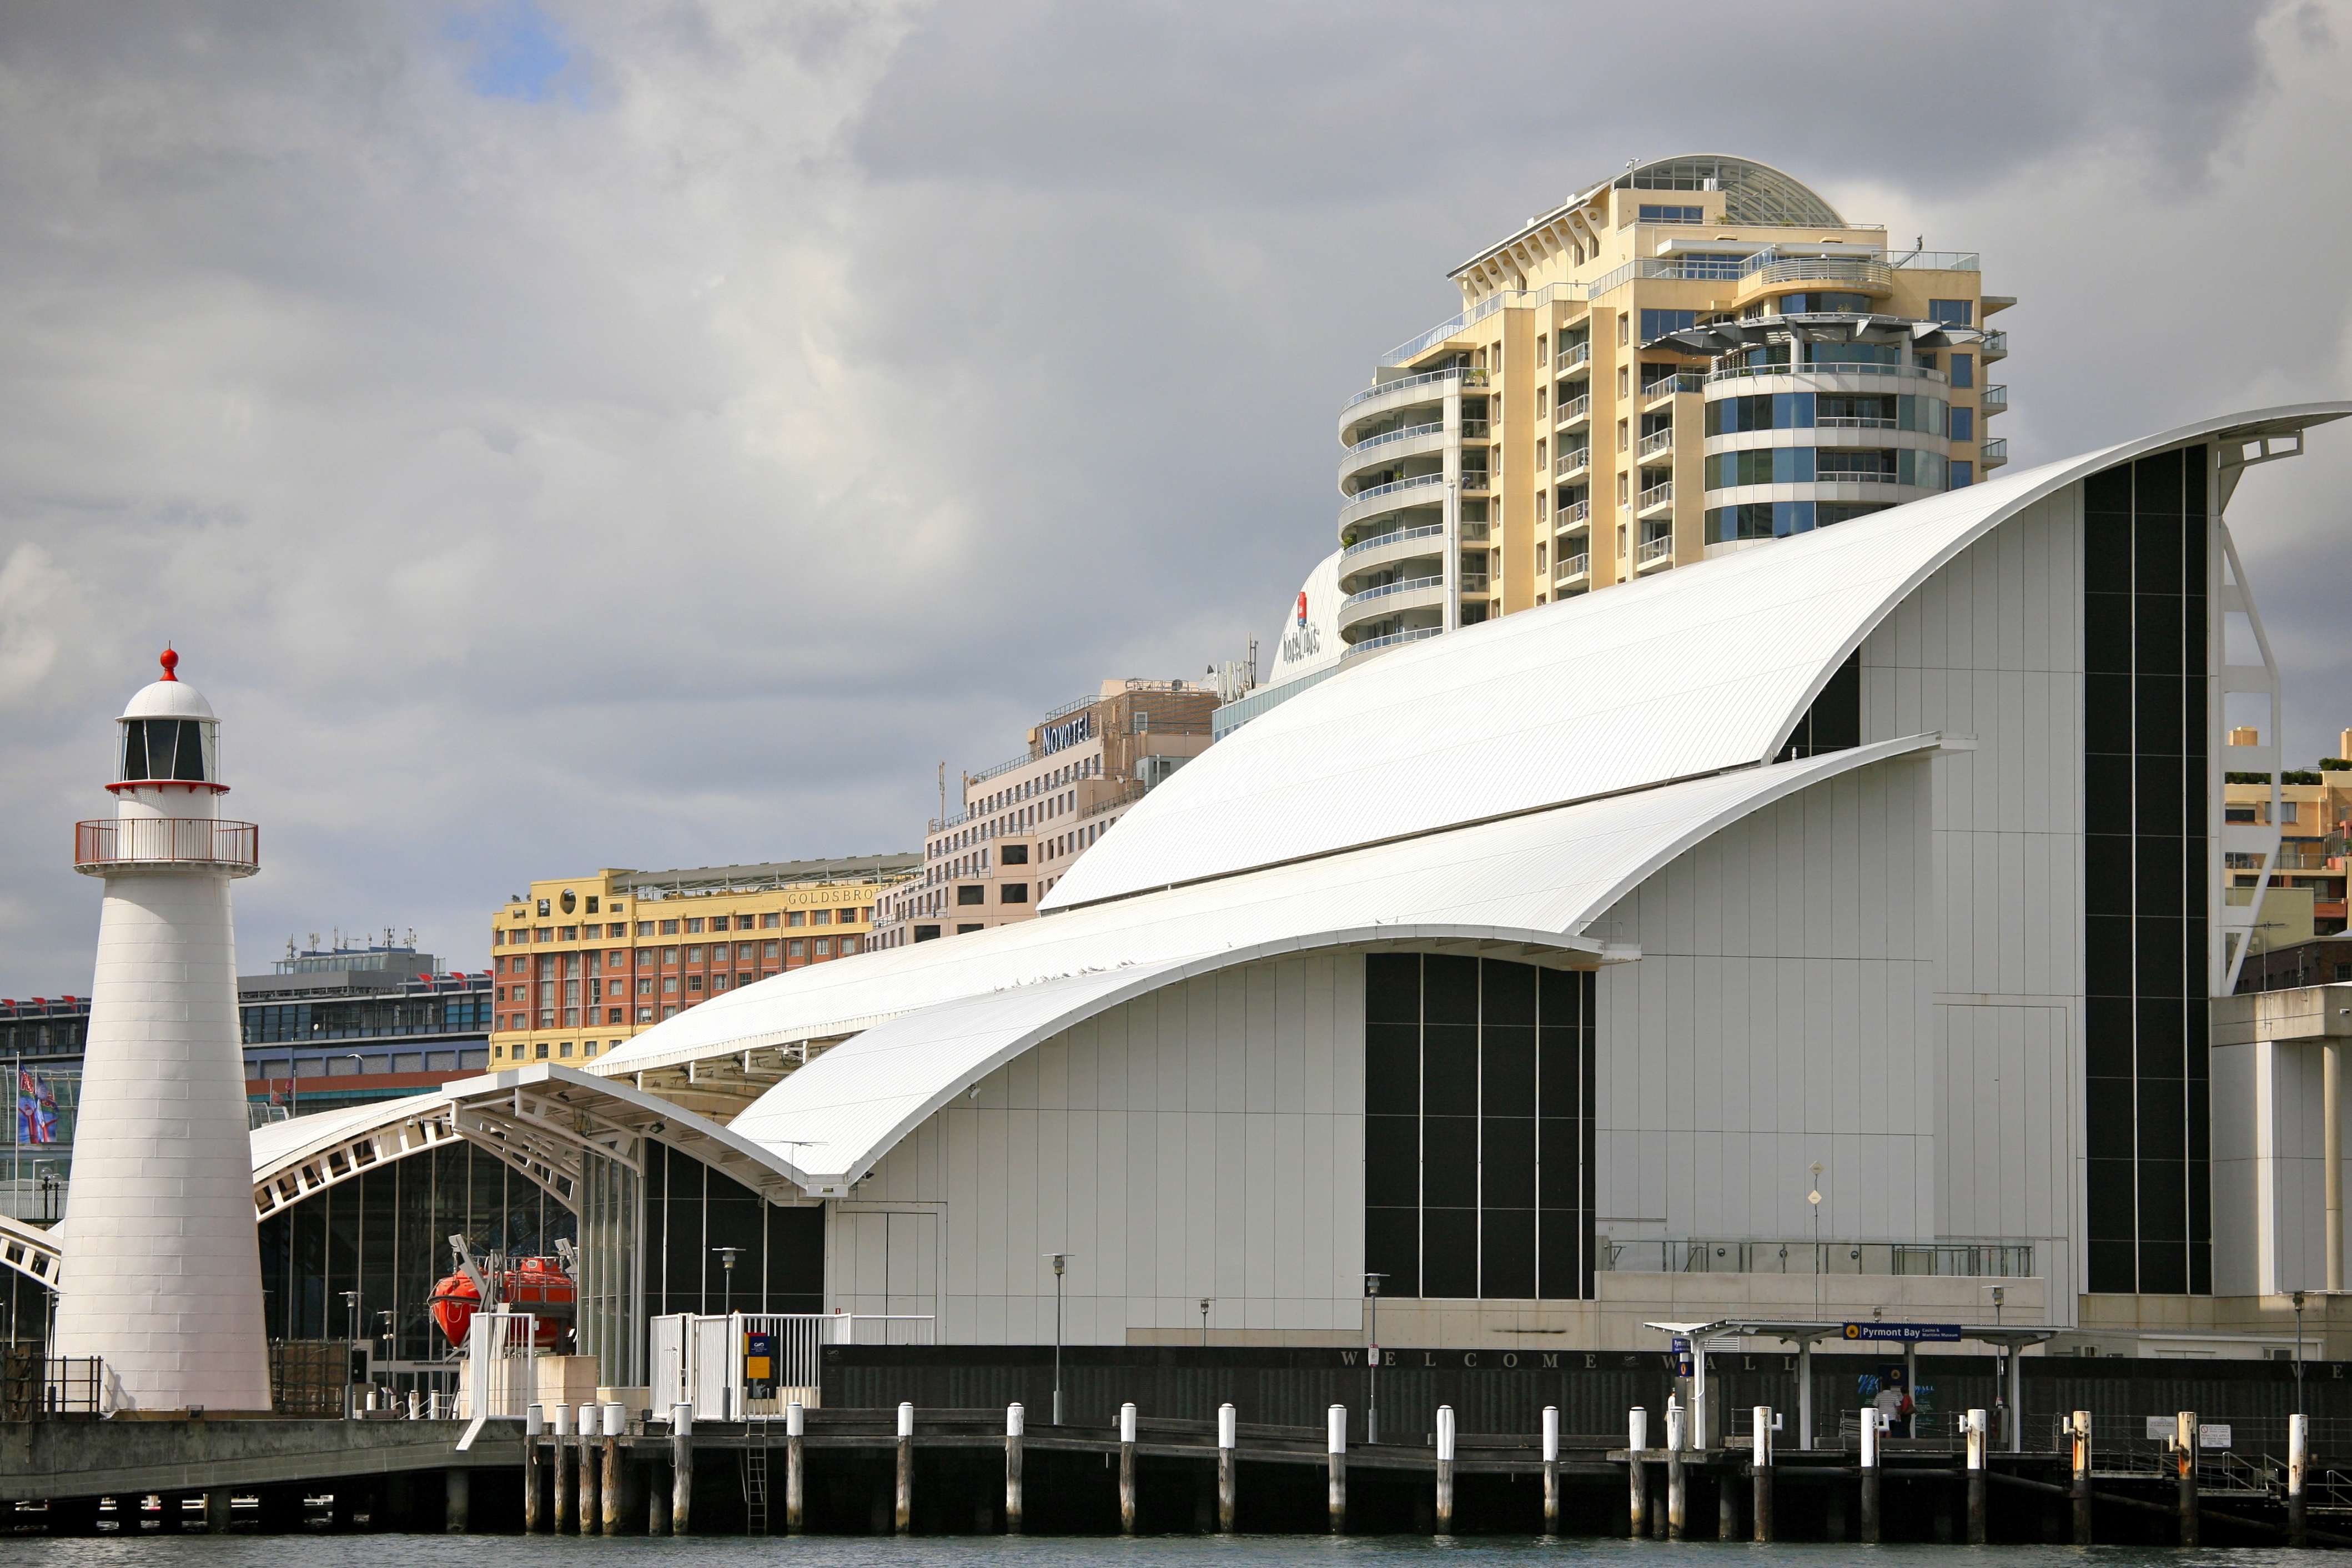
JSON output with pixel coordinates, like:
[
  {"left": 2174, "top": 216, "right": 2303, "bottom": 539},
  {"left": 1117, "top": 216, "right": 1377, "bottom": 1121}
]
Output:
[{"left": 0, "top": 0, "right": 2352, "bottom": 997}]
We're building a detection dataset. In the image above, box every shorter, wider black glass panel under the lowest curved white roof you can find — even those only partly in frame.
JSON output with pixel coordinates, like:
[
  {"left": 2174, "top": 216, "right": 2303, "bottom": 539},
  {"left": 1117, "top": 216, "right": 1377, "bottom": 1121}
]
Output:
[{"left": 1364, "top": 952, "right": 1595, "bottom": 1300}]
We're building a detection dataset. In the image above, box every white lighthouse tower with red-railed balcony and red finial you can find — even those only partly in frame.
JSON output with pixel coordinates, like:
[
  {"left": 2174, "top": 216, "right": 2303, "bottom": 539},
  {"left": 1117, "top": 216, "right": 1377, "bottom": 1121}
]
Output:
[{"left": 49, "top": 649, "right": 270, "bottom": 1413}]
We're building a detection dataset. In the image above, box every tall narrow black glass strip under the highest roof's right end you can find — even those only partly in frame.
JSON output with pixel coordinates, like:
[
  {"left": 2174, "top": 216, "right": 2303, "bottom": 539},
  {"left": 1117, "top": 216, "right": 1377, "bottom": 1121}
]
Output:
[{"left": 2082, "top": 446, "right": 2213, "bottom": 1295}]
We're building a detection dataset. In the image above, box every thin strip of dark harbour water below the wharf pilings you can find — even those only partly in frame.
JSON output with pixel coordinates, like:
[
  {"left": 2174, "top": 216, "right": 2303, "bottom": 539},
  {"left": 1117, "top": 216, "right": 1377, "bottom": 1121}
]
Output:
[{"left": 0, "top": 1535, "right": 2343, "bottom": 1568}]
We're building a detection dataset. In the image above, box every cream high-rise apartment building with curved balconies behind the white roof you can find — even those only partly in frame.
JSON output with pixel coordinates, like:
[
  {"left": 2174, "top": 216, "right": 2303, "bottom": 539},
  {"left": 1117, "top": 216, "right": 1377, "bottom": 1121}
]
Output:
[{"left": 1336, "top": 155, "right": 2013, "bottom": 656}]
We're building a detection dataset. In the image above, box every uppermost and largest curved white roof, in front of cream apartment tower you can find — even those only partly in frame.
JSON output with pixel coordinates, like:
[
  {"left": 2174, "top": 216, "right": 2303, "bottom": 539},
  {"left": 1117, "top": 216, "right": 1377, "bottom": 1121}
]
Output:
[{"left": 1039, "top": 402, "right": 2352, "bottom": 912}]
